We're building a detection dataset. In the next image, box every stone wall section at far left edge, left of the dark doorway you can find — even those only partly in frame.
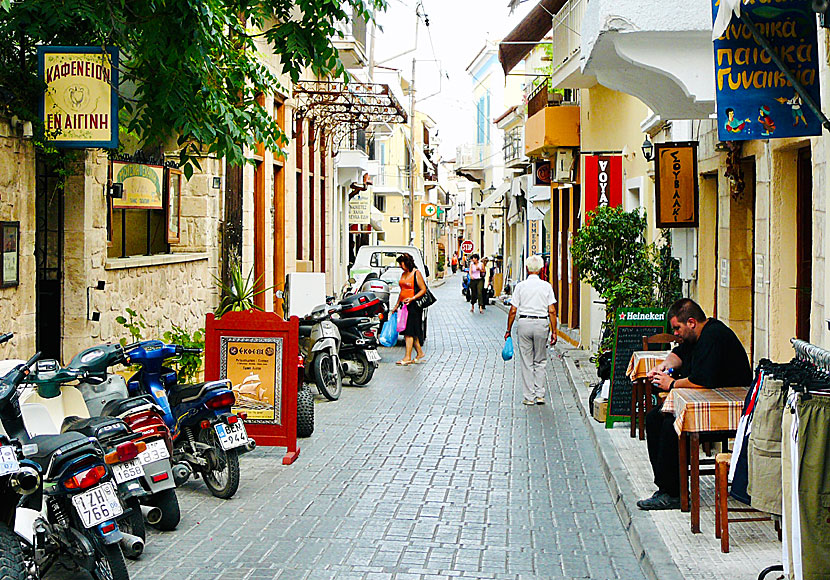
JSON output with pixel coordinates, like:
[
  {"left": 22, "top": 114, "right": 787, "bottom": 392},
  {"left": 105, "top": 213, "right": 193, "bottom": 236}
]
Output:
[{"left": 0, "top": 117, "right": 36, "bottom": 358}]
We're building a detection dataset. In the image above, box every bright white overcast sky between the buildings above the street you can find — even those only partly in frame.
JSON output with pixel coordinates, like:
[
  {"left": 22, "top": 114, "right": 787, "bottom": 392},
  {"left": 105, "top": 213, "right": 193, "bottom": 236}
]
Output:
[{"left": 375, "top": 0, "right": 537, "bottom": 159}]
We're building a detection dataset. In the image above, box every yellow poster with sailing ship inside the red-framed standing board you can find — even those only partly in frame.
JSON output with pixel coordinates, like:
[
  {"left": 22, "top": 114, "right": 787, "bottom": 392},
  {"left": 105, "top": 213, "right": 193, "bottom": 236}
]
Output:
[{"left": 219, "top": 336, "right": 283, "bottom": 425}]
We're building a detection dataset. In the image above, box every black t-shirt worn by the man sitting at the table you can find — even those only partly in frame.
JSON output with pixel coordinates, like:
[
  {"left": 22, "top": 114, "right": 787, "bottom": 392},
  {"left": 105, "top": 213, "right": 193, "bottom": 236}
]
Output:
[{"left": 672, "top": 318, "right": 752, "bottom": 389}]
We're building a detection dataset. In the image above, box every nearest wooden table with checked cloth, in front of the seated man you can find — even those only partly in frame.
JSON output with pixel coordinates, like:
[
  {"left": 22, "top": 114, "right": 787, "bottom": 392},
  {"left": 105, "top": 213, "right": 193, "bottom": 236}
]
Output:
[{"left": 663, "top": 387, "right": 747, "bottom": 534}]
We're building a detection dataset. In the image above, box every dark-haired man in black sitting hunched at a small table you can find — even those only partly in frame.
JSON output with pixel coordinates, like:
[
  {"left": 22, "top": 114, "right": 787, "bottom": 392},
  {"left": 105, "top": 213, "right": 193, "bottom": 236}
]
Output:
[{"left": 637, "top": 298, "right": 752, "bottom": 510}]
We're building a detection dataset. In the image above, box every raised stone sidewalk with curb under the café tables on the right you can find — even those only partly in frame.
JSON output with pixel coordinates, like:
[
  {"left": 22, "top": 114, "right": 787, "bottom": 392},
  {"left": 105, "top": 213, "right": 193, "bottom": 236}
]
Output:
[{"left": 564, "top": 349, "right": 781, "bottom": 580}]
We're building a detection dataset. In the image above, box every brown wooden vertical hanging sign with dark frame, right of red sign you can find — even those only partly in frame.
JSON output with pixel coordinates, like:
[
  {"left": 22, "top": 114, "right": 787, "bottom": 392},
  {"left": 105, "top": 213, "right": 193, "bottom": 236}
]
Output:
[{"left": 654, "top": 142, "right": 698, "bottom": 228}]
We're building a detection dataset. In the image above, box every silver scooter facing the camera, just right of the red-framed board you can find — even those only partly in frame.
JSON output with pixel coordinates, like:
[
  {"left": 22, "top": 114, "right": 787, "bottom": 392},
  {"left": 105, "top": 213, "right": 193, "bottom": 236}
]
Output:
[{"left": 300, "top": 304, "right": 343, "bottom": 401}]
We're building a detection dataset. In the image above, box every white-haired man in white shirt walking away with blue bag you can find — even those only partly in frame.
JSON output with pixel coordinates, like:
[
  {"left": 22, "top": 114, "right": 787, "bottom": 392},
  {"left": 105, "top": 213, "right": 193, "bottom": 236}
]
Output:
[{"left": 504, "top": 256, "right": 556, "bottom": 405}]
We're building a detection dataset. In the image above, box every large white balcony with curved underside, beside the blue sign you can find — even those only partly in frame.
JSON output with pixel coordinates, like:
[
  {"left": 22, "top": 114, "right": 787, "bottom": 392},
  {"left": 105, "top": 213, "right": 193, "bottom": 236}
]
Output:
[{"left": 579, "top": 0, "right": 715, "bottom": 119}]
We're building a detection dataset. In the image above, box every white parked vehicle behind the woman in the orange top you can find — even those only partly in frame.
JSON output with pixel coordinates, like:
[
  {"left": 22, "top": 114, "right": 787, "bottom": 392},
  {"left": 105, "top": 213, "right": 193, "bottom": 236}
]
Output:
[{"left": 349, "top": 245, "right": 430, "bottom": 336}]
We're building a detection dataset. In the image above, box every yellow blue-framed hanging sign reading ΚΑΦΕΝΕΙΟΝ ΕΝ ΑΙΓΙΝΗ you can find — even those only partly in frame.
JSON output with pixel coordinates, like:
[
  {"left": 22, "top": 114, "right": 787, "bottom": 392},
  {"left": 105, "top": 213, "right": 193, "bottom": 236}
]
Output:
[{"left": 37, "top": 46, "right": 118, "bottom": 149}]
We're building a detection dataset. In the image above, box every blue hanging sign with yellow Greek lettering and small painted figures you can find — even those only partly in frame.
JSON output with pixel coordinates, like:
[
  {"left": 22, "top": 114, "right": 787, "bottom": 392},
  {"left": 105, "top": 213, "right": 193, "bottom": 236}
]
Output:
[{"left": 712, "top": 0, "right": 821, "bottom": 141}]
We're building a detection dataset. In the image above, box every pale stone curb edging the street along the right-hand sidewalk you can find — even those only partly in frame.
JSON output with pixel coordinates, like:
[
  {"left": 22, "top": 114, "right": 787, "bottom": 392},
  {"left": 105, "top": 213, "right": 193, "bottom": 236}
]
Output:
[{"left": 562, "top": 349, "right": 684, "bottom": 580}]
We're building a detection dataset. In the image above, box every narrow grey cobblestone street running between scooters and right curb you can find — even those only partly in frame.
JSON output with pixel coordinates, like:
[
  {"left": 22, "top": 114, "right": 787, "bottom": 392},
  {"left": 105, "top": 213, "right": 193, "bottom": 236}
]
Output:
[{"left": 120, "top": 276, "right": 643, "bottom": 580}]
